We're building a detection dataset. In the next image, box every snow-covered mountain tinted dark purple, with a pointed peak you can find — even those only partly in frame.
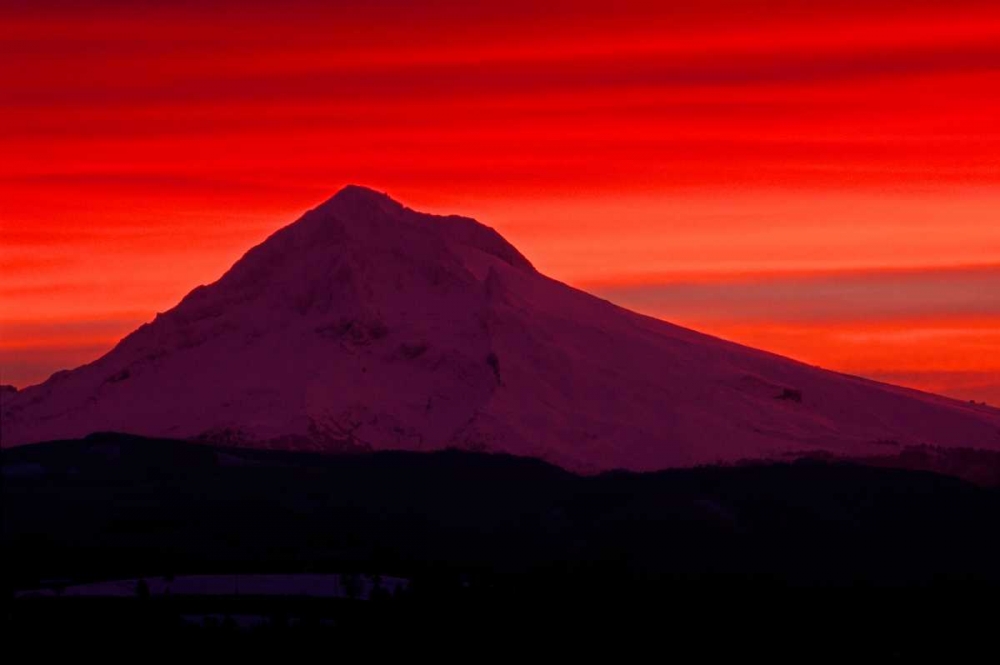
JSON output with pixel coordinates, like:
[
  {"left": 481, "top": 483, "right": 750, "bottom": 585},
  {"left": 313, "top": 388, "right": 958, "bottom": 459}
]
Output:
[{"left": 0, "top": 186, "right": 1000, "bottom": 472}]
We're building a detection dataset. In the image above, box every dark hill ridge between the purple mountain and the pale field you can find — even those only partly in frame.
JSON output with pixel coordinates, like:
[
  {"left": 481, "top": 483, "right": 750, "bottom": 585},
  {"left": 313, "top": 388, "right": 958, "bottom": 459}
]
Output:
[{"left": 3, "top": 435, "right": 1000, "bottom": 587}]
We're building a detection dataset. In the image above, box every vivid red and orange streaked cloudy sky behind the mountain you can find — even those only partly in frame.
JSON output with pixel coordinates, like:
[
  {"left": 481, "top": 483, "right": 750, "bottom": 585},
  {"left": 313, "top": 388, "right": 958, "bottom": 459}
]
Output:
[{"left": 0, "top": 0, "right": 1000, "bottom": 404}]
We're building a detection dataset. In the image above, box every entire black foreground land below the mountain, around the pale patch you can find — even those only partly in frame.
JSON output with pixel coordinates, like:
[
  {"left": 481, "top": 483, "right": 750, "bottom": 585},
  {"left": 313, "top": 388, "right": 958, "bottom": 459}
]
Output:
[{"left": 2, "top": 434, "right": 1000, "bottom": 660}]
